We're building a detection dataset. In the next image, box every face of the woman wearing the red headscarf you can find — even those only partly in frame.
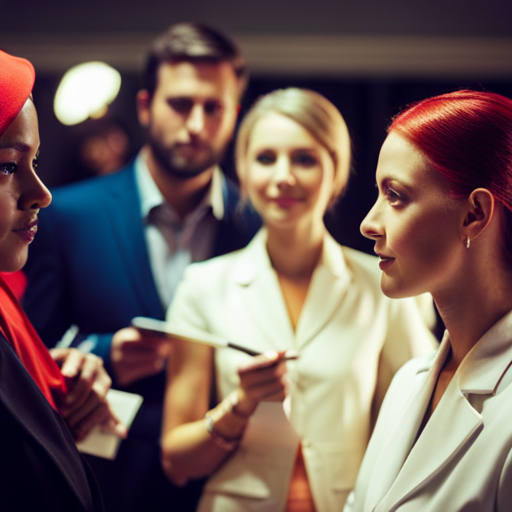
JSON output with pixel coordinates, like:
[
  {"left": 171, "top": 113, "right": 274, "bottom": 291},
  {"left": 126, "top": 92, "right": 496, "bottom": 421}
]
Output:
[{"left": 0, "top": 99, "right": 51, "bottom": 272}]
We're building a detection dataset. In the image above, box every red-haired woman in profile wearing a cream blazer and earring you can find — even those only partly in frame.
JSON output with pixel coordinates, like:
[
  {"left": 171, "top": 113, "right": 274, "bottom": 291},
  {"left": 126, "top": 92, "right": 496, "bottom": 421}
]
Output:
[{"left": 346, "top": 91, "right": 512, "bottom": 512}]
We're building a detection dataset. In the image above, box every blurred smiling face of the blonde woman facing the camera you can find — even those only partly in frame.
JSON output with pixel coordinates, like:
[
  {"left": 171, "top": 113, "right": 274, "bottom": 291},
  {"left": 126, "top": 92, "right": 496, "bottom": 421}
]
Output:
[{"left": 243, "top": 112, "right": 334, "bottom": 233}]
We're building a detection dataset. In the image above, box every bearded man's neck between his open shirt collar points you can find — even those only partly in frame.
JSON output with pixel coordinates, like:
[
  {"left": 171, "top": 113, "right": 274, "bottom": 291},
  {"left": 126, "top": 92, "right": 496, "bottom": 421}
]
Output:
[{"left": 142, "top": 145, "right": 215, "bottom": 219}]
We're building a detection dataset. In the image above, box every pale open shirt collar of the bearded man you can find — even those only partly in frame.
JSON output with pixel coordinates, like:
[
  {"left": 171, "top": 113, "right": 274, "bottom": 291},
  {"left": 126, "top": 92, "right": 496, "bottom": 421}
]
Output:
[{"left": 135, "top": 148, "right": 224, "bottom": 220}]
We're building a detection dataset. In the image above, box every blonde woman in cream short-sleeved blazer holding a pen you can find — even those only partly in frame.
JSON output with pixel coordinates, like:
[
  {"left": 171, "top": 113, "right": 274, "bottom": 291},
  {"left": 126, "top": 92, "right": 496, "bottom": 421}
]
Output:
[{"left": 163, "top": 89, "right": 433, "bottom": 512}]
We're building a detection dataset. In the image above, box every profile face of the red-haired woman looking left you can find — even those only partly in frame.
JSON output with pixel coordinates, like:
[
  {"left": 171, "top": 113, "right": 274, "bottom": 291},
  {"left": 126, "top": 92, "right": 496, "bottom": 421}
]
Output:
[{"left": 361, "top": 132, "right": 466, "bottom": 298}]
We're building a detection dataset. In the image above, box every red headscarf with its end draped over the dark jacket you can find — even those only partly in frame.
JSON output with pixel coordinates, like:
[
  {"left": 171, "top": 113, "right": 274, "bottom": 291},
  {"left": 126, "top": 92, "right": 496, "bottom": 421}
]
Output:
[{"left": 0, "top": 50, "right": 66, "bottom": 409}]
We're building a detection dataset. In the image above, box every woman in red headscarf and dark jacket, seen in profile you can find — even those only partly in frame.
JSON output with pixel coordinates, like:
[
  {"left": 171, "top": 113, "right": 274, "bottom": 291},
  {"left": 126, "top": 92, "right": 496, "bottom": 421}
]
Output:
[{"left": 0, "top": 51, "right": 124, "bottom": 512}]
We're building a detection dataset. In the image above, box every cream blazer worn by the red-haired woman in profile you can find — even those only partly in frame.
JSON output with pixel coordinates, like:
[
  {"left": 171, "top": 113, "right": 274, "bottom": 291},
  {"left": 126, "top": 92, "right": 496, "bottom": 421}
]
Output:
[{"left": 345, "top": 312, "right": 512, "bottom": 512}]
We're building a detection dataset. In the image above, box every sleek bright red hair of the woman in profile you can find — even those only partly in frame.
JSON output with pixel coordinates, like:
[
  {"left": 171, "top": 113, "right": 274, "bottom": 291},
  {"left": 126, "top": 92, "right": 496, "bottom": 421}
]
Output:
[{"left": 388, "top": 90, "right": 512, "bottom": 210}]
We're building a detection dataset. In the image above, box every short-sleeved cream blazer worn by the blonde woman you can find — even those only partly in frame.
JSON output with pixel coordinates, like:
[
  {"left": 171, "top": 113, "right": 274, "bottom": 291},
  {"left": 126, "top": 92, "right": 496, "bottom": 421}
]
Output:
[{"left": 168, "top": 230, "right": 435, "bottom": 512}]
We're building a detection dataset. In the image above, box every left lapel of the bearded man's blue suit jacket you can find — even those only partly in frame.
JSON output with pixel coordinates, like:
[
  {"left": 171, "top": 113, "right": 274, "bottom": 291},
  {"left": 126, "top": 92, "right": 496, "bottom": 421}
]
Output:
[{"left": 106, "top": 164, "right": 165, "bottom": 319}]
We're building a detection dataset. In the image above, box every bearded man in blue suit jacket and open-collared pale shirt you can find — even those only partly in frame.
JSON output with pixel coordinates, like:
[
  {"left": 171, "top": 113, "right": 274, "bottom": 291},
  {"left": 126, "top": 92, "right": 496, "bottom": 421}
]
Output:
[{"left": 24, "top": 23, "right": 259, "bottom": 512}]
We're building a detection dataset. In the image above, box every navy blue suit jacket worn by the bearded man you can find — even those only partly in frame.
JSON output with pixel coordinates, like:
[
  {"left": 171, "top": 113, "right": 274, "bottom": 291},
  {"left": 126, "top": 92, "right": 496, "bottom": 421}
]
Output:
[{"left": 23, "top": 163, "right": 260, "bottom": 512}]
